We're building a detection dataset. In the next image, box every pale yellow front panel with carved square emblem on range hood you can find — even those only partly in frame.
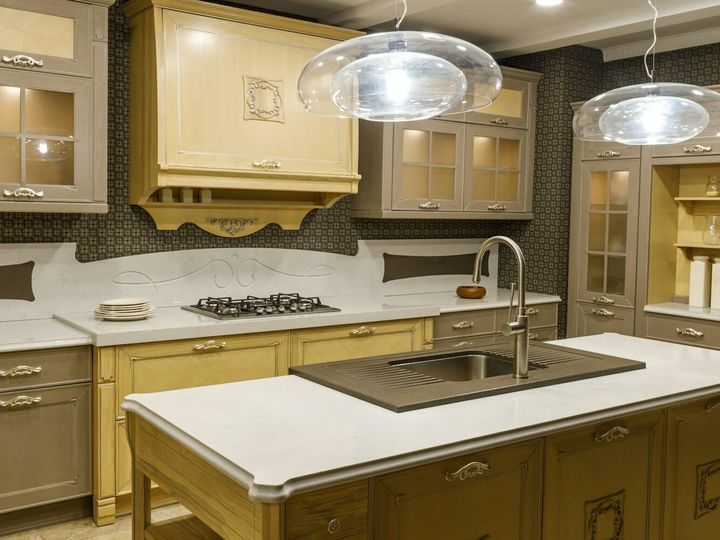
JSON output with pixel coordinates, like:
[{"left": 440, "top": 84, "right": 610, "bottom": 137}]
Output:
[{"left": 159, "top": 10, "right": 357, "bottom": 180}]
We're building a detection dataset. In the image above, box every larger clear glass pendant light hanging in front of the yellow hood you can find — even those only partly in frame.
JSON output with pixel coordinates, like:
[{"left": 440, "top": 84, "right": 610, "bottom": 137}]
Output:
[{"left": 298, "top": 0, "right": 502, "bottom": 122}]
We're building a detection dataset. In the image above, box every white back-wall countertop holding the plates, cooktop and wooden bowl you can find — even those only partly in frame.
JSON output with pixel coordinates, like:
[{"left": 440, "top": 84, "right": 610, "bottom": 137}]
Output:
[{"left": 56, "top": 289, "right": 560, "bottom": 347}]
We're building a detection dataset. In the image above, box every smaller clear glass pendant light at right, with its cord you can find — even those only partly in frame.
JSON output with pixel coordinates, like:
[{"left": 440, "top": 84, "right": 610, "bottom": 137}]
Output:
[{"left": 573, "top": 0, "right": 720, "bottom": 145}]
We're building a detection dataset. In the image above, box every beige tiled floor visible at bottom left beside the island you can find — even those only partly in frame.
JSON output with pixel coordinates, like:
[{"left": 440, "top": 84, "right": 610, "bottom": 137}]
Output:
[{"left": 0, "top": 504, "right": 188, "bottom": 540}]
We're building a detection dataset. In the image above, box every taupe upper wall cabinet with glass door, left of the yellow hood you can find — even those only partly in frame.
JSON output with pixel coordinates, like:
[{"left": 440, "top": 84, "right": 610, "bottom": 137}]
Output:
[{"left": 0, "top": 0, "right": 115, "bottom": 213}]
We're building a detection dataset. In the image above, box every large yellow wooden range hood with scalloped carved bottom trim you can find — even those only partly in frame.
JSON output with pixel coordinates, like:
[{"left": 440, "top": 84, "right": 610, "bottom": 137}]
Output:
[{"left": 125, "top": 0, "right": 360, "bottom": 236}]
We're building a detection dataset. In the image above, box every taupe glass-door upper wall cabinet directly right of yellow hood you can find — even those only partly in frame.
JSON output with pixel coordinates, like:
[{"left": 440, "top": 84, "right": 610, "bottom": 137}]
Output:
[{"left": 352, "top": 68, "right": 540, "bottom": 219}]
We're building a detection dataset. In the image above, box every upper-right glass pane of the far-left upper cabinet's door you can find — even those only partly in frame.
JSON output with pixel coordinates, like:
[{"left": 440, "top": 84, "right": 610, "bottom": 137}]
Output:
[{"left": 25, "top": 89, "right": 75, "bottom": 137}]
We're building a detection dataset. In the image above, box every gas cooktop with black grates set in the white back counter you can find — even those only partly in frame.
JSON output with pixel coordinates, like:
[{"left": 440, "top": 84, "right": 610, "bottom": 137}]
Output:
[{"left": 182, "top": 293, "right": 340, "bottom": 319}]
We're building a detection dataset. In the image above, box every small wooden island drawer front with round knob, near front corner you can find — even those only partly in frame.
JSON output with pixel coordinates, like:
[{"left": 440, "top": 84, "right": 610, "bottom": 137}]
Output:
[{"left": 285, "top": 480, "right": 368, "bottom": 540}]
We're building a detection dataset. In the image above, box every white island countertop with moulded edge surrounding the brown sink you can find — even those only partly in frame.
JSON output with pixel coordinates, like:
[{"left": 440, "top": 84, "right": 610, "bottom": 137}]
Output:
[{"left": 123, "top": 334, "right": 720, "bottom": 502}]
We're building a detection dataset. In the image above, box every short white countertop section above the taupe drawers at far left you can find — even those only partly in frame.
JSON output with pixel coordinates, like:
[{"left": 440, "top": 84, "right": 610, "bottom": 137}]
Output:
[{"left": 0, "top": 319, "right": 92, "bottom": 353}]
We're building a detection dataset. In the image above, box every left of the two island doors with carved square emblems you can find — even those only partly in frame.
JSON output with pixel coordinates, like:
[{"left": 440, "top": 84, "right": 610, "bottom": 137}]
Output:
[{"left": 543, "top": 411, "right": 665, "bottom": 540}]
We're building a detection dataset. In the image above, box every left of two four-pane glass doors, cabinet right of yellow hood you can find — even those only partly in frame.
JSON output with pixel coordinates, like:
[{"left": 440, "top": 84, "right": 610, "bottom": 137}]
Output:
[{"left": 392, "top": 120, "right": 463, "bottom": 214}]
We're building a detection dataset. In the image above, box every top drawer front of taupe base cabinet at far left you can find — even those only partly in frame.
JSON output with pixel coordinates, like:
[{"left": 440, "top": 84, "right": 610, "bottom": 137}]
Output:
[{"left": 0, "top": 347, "right": 92, "bottom": 392}]
